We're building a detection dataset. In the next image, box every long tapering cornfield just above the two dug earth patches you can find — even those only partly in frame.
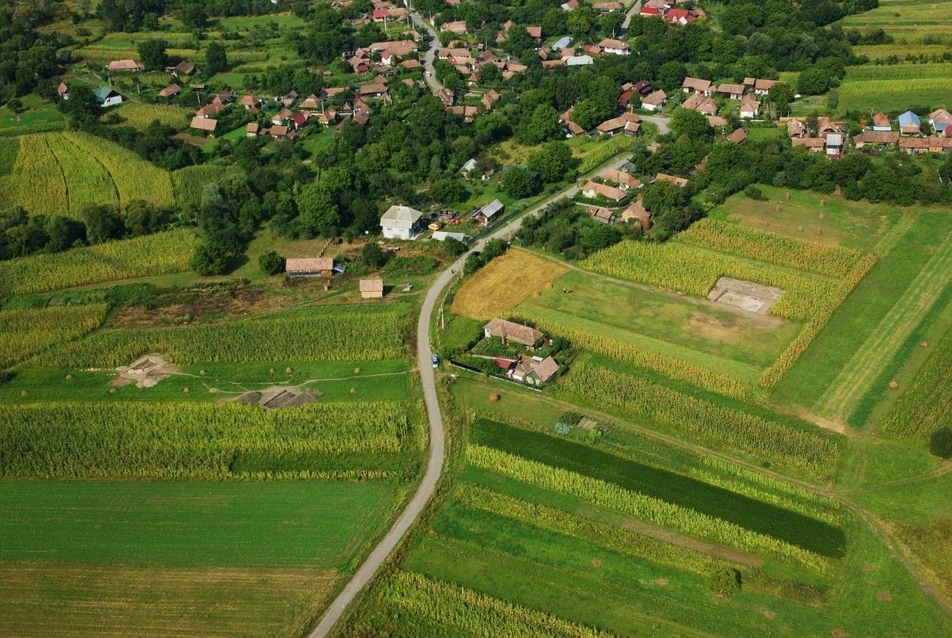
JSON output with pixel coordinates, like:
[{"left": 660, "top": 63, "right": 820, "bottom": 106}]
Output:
[{"left": 30, "top": 304, "right": 408, "bottom": 368}]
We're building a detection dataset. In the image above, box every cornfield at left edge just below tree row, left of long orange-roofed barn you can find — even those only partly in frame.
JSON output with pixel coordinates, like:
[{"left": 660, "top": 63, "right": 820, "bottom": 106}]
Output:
[{"left": 0, "top": 229, "right": 198, "bottom": 296}]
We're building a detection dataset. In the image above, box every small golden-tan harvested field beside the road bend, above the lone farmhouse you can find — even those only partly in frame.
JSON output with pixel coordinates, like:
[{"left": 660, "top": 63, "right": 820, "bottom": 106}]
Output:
[{"left": 453, "top": 249, "right": 567, "bottom": 319}]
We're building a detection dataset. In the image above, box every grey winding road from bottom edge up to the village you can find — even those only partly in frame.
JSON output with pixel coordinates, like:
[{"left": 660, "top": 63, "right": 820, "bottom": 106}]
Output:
[{"left": 309, "top": 153, "right": 644, "bottom": 638}]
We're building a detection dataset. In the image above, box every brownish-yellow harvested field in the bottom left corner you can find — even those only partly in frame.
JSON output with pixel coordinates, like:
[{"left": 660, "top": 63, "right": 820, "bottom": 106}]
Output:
[{"left": 0, "top": 562, "right": 337, "bottom": 638}]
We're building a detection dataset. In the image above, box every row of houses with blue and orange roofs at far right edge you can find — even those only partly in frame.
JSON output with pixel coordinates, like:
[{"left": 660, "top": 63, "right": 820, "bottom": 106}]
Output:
[{"left": 787, "top": 109, "right": 952, "bottom": 158}]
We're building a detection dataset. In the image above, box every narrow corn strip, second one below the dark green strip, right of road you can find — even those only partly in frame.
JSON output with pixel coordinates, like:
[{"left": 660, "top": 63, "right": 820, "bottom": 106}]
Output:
[{"left": 453, "top": 483, "right": 736, "bottom": 576}]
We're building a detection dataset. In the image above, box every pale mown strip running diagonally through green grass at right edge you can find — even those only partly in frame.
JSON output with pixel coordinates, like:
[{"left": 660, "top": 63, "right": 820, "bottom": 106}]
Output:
[{"left": 814, "top": 228, "right": 952, "bottom": 419}]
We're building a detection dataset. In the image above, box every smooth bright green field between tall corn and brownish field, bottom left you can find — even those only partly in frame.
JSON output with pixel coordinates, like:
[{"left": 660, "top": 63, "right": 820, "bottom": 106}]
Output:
[{"left": 0, "top": 481, "right": 394, "bottom": 569}]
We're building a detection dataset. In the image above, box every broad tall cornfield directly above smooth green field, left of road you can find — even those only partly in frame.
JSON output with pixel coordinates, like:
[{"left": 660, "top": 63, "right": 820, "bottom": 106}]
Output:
[{"left": 0, "top": 402, "right": 418, "bottom": 479}]
